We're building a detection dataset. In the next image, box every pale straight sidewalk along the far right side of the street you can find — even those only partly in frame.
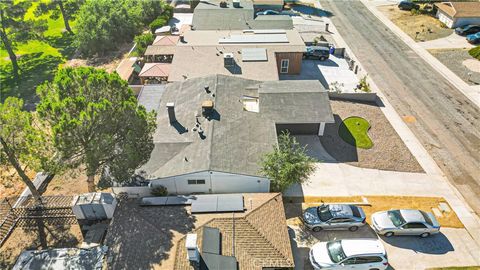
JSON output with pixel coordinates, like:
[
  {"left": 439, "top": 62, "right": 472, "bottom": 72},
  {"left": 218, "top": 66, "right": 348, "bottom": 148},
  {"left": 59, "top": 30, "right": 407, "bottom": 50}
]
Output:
[{"left": 360, "top": 0, "right": 480, "bottom": 107}]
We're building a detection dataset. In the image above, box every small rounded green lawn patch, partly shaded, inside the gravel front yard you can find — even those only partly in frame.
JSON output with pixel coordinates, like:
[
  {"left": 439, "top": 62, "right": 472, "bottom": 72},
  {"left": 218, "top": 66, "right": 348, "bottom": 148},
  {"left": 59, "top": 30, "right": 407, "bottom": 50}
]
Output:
[{"left": 338, "top": 116, "right": 373, "bottom": 149}]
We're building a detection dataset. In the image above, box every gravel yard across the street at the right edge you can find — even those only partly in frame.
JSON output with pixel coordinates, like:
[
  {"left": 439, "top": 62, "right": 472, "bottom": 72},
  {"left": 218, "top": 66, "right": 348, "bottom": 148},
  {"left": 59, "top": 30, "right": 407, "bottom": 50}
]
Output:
[{"left": 429, "top": 49, "right": 480, "bottom": 85}]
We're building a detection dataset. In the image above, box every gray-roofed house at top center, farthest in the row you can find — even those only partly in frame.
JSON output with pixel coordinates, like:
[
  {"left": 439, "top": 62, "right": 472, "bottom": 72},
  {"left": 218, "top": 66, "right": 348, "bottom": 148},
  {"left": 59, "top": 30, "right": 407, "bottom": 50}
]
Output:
[{"left": 192, "top": 0, "right": 293, "bottom": 30}]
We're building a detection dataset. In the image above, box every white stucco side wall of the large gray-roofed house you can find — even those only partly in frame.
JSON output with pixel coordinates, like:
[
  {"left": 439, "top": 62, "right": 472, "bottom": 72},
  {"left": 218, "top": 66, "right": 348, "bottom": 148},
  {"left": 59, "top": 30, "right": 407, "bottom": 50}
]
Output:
[{"left": 151, "top": 171, "right": 270, "bottom": 194}]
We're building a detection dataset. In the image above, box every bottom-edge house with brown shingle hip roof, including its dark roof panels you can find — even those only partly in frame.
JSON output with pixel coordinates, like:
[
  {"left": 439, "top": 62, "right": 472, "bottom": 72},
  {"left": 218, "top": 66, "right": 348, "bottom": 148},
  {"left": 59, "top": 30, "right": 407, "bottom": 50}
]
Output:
[{"left": 173, "top": 193, "right": 295, "bottom": 270}]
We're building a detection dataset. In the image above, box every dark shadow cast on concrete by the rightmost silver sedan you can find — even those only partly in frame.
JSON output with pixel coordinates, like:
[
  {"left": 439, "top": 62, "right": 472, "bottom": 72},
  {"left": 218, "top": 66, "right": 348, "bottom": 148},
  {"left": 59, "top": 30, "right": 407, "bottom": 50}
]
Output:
[{"left": 382, "top": 232, "right": 455, "bottom": 255}]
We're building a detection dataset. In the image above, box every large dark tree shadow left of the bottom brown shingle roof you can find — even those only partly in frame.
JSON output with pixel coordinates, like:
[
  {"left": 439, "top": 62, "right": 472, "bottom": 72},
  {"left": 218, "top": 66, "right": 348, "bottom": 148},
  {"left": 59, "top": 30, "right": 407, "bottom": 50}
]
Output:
[{"left": 105, "top": 200, "right": 196, "bottom": 269}]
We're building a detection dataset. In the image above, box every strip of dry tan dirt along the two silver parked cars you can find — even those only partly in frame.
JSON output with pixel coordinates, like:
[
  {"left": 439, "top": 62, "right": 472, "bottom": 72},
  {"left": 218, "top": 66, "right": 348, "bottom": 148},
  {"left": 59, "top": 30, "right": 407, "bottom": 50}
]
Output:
[{"left": 284, "top": 196, "right": 464, "bottom": 228}]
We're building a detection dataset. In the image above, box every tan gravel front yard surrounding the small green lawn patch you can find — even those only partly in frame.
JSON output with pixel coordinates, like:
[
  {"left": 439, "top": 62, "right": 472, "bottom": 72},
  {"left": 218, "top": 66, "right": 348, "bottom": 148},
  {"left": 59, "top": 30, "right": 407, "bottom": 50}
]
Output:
[{"left": 320, "top": 100, "right": 423, "bottom": 172}]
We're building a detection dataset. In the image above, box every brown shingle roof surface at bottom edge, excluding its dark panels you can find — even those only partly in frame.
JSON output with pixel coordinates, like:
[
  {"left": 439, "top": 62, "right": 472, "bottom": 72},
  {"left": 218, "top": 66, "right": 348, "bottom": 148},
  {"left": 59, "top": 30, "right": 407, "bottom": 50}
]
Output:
[{"left": 174, "top": 193, "right": 294, "bottom": 270}]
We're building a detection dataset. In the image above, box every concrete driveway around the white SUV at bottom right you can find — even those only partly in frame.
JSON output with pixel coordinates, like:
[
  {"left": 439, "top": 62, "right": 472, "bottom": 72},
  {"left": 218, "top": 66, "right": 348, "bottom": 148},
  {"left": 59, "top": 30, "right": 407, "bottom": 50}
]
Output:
[{"left": 289, "top": 225, "right": 480, "bottom": 270}]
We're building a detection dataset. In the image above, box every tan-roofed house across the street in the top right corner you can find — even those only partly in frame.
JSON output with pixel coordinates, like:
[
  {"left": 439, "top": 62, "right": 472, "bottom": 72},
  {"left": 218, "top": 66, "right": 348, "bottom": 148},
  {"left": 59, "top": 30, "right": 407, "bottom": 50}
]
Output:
[{"left": 435, "top": 2, "right": 480, "bottom": 28}]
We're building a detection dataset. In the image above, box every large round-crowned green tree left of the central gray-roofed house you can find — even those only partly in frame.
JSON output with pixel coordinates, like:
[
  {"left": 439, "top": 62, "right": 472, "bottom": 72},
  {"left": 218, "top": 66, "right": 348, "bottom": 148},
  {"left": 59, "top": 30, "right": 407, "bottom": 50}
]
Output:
[{"left": 37, "top": 67, "right": 155, "bottom": 192}]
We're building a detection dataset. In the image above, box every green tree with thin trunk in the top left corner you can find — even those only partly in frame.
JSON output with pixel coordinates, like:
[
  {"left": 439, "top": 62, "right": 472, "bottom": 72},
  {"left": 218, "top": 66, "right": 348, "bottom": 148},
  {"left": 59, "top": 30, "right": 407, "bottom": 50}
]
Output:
[{"left": 0, "top": 1, "right": 48, "bottom": 79}]
